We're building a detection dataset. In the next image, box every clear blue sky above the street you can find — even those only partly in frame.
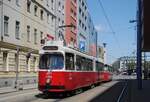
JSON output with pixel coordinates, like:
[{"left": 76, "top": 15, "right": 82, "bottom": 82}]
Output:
[{"left": 87, "top": 0, "right": 137, "bottom": 64}]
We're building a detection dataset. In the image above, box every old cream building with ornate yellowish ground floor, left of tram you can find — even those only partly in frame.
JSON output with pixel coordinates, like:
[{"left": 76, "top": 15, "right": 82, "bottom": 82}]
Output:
[{"left": 0, "top": 0, "right": 56, "bottom": 87}]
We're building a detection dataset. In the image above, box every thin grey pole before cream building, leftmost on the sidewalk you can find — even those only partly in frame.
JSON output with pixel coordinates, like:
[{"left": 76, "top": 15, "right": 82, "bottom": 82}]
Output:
[{"left": 15, "top": 47, "right": 19, "bottom": 89}]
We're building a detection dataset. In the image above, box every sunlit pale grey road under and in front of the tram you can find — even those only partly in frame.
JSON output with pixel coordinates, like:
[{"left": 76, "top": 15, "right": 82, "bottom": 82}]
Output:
[{"left": 0, "top": 81, "right": 118, "bottom": 102}]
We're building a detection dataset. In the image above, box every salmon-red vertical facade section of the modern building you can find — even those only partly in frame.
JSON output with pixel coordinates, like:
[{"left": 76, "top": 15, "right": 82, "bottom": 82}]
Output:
[{"left": 65, "top": 0, "right": 77, "bottom": 47}]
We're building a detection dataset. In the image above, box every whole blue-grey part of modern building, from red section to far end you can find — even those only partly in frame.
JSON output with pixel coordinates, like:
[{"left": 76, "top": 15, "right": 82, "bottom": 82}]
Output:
[{"left": 77, "top": 0, "right": 97, "bottom": 57}]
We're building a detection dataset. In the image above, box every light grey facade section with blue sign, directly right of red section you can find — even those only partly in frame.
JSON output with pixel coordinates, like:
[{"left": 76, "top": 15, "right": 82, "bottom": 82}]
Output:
[{"left": 77, "top": 0, "right": 89, "bottom": 52}]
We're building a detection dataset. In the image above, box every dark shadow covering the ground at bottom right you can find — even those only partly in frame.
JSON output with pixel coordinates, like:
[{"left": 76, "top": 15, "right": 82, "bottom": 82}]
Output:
[{"left": 90, "top": 79, "right": 150, "bottom": 102}]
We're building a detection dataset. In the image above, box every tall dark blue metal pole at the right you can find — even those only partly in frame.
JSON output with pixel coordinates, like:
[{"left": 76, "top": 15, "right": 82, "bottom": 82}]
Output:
[{"left": 136, "top": 0, "right": 142, "bottom": 90}]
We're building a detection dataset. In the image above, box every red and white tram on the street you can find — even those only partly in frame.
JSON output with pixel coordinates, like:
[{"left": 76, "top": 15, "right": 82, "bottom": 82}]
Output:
[{"left": 38, "top": 41, "right": 111, "bottom": 92}]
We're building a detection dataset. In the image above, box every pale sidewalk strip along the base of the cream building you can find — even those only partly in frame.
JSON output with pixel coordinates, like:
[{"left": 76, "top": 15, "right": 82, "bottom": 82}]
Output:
[{"left": 0, "top": 84, "right": 38, "bottom": 94}]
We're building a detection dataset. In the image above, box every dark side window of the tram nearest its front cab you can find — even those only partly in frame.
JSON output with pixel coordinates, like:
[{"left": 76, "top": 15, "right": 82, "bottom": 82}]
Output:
[{"left": 66, "top": 53, "right": 75, "bottom": 70}]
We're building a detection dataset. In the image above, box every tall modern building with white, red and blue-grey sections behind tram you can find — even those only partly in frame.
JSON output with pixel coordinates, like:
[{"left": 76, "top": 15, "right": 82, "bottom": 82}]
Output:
[{"left": 56, "top": 0, "right": 97, "bottom": 57}]
